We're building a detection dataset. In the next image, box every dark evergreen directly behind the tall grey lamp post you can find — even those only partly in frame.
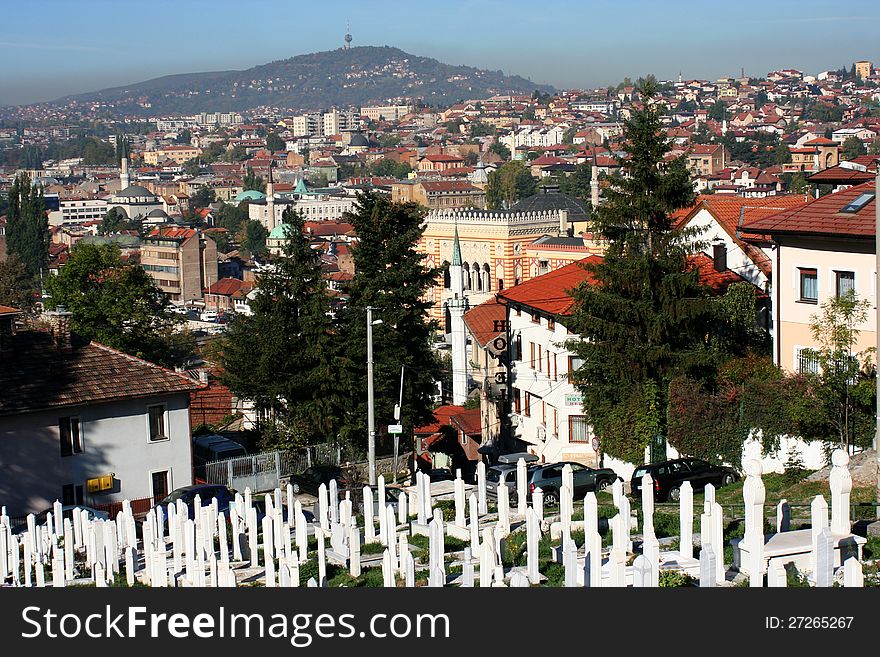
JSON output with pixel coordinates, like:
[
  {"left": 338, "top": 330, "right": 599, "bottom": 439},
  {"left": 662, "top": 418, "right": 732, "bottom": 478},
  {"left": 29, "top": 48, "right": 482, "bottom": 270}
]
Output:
[{"left": 339, "top": 193, "right": 440, "bottom": 448}]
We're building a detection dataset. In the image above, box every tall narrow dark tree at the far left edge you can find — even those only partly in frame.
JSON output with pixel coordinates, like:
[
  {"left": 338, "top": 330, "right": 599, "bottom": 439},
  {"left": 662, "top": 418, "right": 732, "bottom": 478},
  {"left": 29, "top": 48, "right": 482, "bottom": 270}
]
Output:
[{"left": 6, "top": 173, "right": 49, "bottom": 280}]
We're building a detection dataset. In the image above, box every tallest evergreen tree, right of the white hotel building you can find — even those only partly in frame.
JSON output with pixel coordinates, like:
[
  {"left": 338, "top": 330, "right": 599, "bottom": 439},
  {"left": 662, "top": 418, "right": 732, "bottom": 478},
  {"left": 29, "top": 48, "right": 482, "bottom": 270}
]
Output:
[{"left": 571, "top": 84, "right": 715, "bottom": 462}]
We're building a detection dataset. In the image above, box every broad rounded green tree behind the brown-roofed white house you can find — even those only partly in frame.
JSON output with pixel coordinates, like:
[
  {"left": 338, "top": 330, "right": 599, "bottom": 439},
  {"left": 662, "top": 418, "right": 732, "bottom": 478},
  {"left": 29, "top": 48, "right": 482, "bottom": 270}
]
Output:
[{"left": 46, "top": 243, "right": 195, "bottom": 367}]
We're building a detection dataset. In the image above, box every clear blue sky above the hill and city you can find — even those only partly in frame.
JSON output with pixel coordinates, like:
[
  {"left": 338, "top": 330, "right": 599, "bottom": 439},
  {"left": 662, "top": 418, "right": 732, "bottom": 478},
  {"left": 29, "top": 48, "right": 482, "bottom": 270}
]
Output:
[{"left": 0, "top": 0, "right": 880, "bottom": 105}]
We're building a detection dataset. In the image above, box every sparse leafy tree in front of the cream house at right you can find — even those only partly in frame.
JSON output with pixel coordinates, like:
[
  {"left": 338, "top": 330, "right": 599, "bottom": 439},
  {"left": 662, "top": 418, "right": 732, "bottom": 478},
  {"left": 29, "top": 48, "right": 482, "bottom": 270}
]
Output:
[{"left": 810, "top": 290, "right": 876, "bottom": 449}]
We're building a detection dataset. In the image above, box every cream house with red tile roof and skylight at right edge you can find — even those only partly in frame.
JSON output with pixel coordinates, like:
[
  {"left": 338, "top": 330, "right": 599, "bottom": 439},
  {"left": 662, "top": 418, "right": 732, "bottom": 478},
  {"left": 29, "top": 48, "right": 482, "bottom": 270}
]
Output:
[{"left": 746, "top": 182, "right": 877, "bottom": 372}]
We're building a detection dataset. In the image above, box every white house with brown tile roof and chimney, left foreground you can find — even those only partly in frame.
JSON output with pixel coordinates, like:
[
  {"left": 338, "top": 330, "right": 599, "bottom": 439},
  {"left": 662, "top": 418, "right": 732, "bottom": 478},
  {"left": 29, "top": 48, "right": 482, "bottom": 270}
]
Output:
[{"left": 0, "top": 307, "right": 199, "bottom": 515}]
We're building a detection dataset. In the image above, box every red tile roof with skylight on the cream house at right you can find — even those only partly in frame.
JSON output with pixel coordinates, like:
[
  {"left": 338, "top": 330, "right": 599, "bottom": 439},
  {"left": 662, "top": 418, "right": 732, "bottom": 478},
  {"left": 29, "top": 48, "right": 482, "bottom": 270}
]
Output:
[{"left": 747, "top": 181, "right": 876, "bottom": 240}]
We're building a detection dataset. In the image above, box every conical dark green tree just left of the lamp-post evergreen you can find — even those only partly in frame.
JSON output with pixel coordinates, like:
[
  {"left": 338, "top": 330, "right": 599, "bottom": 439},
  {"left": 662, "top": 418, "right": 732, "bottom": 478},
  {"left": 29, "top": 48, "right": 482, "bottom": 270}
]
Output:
[{"left": 220, "top": 209, "right": 342, "bottom": 448}]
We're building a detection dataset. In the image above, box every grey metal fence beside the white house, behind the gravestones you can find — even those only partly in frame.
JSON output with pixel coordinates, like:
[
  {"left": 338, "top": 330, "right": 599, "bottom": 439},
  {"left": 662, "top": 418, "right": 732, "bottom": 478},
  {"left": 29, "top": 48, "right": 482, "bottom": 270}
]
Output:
[{"left": 203, "top": 443, "right": 342, "bottom": 492}]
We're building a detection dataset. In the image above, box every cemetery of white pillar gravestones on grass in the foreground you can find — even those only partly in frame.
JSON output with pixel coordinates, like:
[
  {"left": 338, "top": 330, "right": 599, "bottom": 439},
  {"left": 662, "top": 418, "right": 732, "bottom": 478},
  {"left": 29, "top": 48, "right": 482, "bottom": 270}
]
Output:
[{"left": 0, "top": 450, "right": 880, "bottom": 588}]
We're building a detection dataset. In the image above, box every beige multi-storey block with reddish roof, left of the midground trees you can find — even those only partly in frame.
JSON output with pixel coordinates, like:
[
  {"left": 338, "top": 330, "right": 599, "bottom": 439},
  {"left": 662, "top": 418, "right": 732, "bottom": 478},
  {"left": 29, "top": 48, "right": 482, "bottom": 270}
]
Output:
[{"left": 141, "top": 226, "right": 217, "bottom": 302}]
